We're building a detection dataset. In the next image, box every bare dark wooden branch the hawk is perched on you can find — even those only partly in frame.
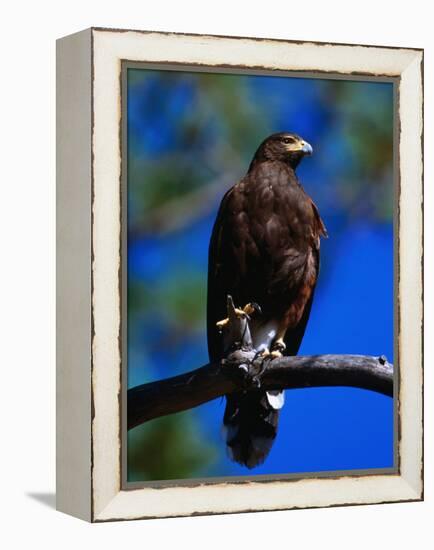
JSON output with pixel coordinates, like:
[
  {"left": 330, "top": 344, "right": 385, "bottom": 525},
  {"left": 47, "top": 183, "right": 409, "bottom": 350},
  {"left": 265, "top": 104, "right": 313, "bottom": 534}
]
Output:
[{"left": 128, "top": 351, "right": 393, "bottom": 429}]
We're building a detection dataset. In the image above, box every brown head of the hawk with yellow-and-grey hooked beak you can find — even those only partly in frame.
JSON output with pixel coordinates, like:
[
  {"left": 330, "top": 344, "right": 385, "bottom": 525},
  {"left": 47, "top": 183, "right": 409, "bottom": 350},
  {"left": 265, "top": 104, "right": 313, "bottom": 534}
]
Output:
[{"left": 254, "top": 132, "right": 312, "bottom": 168}]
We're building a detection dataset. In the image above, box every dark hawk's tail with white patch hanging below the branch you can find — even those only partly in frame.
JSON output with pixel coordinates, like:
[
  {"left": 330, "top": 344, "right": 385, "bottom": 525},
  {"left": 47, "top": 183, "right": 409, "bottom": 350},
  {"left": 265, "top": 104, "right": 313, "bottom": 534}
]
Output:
[{"left": 223, "top": 391, "right": 284, "bottom": 468}]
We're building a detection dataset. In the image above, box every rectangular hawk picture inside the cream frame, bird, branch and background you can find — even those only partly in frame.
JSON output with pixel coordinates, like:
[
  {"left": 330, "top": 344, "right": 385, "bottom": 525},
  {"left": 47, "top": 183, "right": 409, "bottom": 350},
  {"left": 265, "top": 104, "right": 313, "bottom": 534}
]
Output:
[{"left": 122, "top": 67, "right": 397, "bottom": 484}]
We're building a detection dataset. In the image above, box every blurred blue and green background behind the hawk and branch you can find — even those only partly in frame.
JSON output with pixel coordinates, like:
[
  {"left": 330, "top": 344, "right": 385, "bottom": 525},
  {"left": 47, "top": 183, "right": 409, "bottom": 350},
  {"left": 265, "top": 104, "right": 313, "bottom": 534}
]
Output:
[{"left": 127, "top": 69, "right": 394, "bottom": 481}]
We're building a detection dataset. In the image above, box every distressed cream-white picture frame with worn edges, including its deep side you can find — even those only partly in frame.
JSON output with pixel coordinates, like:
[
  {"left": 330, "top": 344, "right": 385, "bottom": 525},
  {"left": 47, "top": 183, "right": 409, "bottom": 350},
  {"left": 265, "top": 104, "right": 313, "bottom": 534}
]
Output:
[{"left": 57, "top": 28, "right": 423, "bottom": 522}]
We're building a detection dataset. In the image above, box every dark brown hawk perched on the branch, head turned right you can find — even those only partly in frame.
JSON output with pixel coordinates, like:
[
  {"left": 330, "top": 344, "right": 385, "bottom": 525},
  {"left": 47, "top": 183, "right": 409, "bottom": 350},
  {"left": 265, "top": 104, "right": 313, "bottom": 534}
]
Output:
[{"left": 207, "top": 132, "right": 326, "bottom": 468}]
